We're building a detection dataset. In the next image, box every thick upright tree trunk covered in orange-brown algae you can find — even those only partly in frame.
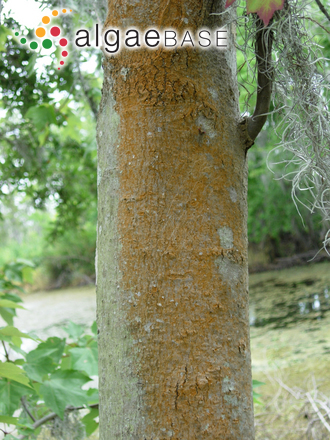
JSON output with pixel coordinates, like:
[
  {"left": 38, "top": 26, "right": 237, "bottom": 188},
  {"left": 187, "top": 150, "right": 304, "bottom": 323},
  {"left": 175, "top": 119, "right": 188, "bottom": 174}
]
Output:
[{"left": 97, "top": 0, "right": 254, "bottom": 440}]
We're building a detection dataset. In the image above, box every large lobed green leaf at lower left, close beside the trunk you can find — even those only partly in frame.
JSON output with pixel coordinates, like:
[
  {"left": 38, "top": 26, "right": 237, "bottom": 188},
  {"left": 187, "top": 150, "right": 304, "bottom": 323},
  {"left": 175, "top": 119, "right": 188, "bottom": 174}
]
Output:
[{"left": 40, "top": 370, "right": 90, "bottom": 419}]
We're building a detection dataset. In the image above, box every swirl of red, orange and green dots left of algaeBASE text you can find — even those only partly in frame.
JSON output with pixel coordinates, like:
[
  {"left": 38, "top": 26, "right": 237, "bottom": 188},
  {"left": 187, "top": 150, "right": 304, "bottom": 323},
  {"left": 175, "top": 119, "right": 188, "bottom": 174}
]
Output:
[{"left": 13, "top": 9, "right": 72, "bottom": 70}]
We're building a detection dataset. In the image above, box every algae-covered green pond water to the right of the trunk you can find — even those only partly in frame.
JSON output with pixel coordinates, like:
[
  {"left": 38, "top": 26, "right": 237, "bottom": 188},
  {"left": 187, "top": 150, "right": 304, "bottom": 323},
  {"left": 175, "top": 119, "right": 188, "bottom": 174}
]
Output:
[{"left": 250, "top": 262, "right": 330, "bottom": 370}]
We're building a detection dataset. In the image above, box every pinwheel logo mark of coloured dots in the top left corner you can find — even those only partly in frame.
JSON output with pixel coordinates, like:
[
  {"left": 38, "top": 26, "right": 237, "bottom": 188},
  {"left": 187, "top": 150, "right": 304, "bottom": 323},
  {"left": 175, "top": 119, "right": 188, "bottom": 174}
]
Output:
[{"left": 13, "top": 9, "right": 72, "bottom": 70}]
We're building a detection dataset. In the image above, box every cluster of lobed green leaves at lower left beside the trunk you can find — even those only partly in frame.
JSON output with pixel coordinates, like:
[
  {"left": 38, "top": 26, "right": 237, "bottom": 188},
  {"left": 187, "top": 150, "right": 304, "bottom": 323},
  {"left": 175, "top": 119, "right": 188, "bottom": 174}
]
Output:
[{"left": 0, "top": 260, "right": 98, "bottom": 439}]
